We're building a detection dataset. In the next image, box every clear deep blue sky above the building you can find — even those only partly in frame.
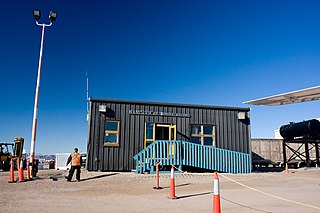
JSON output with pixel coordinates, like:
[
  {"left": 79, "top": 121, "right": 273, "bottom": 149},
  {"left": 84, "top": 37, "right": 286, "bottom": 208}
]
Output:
[{"left": 0, "top": 0, "right": 320, "bottom": 154}]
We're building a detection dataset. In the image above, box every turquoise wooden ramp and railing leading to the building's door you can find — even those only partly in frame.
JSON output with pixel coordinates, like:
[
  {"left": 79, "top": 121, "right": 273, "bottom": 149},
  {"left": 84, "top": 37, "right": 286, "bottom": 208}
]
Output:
[{"left": 134, "top": 141, "right": 251, "bottom": 174}]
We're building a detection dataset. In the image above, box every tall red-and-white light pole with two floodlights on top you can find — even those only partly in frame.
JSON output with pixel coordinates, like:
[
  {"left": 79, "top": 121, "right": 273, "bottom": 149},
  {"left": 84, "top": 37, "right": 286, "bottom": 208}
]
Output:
[{"left": 28, "top": 10, "right": 57, "bottom": 178}]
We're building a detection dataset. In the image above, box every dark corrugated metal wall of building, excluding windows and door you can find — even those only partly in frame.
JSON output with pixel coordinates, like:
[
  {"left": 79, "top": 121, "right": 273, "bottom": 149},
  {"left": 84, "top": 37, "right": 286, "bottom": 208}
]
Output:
[{"left": 87, "top": 99, "right": 251, "bottom": 171}]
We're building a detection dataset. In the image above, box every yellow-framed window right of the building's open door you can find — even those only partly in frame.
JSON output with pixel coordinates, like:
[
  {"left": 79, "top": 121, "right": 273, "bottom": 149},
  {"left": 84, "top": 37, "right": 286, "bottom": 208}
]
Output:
[{"left": 191, "top": 125, "right": 215, "bottom": 146}]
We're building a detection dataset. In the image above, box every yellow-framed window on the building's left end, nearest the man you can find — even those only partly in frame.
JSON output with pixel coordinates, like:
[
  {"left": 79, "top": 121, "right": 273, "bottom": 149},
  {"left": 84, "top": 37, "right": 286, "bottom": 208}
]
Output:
[{"left": 104, "top": 120, "right": 120, "bottom": 146}]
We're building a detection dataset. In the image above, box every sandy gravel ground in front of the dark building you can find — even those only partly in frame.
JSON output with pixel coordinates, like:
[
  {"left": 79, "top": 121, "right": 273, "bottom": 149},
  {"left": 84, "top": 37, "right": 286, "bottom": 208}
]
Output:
[{"left": 0, "top": 168, "right": 320, "bottom": 213}]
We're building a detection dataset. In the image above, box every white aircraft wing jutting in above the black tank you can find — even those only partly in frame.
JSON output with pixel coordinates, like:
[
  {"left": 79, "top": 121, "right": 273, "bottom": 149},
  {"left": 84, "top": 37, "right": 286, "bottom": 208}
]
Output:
[{"left": 243, "top": 86, "right": 320, "bottom": 106}]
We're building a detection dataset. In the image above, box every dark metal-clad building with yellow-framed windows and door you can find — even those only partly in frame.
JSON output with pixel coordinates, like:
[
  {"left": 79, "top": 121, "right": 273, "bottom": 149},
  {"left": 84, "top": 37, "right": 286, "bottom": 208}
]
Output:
[{"left": 87, "top": 98, "right": 251, "bottom": 171}]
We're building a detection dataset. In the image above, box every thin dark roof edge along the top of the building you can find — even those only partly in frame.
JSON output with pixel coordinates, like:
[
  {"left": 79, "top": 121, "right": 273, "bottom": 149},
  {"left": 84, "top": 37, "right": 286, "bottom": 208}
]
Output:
[{"left": 89, "top": 97, "right": 250, "bottom": 112}]
